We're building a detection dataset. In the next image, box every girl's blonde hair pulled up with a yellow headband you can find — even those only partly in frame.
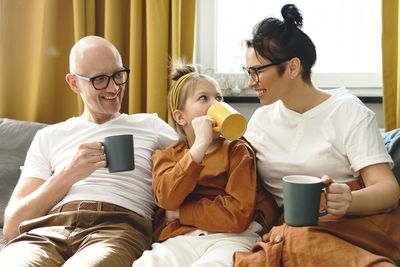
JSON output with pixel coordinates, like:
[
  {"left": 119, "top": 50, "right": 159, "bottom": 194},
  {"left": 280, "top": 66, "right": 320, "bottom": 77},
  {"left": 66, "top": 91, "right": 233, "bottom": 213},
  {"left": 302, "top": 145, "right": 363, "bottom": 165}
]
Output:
[{"left": 168, "top": 59, "right": 219, "bottom": 141}]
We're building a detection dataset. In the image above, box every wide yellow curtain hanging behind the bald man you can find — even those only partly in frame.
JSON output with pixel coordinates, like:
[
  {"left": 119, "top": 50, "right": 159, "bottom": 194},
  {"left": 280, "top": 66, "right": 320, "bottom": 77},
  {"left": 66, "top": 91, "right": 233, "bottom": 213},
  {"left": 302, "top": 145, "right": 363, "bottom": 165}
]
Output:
[{"left": 0, "top": 0, "right": 195, "bottom": 123}]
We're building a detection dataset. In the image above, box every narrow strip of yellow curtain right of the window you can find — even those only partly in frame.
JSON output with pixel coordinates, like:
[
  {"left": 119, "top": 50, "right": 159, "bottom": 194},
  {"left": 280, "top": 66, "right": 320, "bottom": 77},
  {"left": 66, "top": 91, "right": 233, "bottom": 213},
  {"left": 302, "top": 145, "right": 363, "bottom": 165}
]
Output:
[{"left": 382, "top": 0, "right": 400, "bottom": 131}]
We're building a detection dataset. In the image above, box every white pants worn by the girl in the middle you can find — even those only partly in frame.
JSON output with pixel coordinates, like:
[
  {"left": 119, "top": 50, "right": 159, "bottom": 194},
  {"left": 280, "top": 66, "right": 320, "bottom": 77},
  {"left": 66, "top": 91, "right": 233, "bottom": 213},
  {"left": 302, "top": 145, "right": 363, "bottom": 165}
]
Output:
[{"left": 132, "top": 222, "right": 262, "bottom": 267}]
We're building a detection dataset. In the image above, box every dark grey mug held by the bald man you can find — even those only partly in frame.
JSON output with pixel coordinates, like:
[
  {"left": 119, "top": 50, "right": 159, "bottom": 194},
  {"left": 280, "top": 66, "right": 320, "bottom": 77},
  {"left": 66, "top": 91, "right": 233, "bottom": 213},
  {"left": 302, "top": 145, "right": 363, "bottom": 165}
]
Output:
[{"left": 101, "top": 134, "right": 135, "bottom": 172}]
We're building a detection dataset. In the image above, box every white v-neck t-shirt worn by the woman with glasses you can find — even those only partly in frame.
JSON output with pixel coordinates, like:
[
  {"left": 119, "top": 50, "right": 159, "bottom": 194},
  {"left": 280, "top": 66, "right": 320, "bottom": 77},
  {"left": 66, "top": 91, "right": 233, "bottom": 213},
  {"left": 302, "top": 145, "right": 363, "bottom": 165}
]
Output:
[{"left": 245, "top": 88, "right": 393, "bottom": 206}]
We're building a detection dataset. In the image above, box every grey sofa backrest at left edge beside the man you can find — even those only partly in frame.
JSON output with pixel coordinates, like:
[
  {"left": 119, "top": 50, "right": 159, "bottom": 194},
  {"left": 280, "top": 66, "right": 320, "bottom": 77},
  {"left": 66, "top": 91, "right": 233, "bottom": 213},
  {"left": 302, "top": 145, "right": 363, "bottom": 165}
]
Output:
[{"left": 0, "top": 118, "right": 47, "bottom": 227}]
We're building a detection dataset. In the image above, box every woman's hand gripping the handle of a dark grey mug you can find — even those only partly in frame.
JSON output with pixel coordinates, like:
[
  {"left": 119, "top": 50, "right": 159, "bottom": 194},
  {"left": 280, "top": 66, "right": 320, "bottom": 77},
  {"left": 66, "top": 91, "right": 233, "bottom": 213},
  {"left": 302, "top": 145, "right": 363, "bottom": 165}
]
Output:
[{"left": 322, "top": 175, "right": 352, "bottom": 216}]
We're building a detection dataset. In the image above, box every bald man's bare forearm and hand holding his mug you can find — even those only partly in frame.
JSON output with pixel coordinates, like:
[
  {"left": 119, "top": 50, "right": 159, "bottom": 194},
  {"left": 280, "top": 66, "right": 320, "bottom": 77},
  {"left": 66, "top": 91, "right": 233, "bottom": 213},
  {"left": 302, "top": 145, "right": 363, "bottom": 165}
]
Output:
[{"left": 3, "top": 142, "right": 106, "bottom": 243}]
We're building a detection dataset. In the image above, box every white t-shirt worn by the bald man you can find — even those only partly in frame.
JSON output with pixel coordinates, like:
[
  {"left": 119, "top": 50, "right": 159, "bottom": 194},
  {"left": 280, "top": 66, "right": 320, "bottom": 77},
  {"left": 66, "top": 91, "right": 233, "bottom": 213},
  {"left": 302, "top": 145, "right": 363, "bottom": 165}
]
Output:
[{"left": 20, "top": 114, "right": 178, "bottom": 218}]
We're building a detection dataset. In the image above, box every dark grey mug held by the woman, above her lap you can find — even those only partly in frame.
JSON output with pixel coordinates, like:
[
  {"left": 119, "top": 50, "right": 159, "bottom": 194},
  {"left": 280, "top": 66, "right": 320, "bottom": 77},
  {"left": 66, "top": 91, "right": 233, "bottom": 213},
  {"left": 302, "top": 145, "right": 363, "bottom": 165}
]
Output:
[{"left": 283, "top": 175, "right": 328, "bottom": 226}]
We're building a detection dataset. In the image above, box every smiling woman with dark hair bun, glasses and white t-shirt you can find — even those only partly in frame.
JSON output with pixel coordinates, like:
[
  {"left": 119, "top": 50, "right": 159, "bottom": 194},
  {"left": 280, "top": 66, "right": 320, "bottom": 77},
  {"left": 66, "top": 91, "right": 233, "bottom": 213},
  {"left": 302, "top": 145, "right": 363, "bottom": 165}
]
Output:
[{"left": 234, "top": 4, "right": 400, "bottom": 266}]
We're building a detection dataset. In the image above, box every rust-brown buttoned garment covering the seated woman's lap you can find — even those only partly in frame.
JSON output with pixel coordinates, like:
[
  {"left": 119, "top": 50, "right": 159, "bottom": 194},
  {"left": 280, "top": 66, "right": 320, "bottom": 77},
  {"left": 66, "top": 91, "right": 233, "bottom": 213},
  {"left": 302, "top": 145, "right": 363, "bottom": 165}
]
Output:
[{"left": 234, "top": 203, "right": 400, "bottom": 267}]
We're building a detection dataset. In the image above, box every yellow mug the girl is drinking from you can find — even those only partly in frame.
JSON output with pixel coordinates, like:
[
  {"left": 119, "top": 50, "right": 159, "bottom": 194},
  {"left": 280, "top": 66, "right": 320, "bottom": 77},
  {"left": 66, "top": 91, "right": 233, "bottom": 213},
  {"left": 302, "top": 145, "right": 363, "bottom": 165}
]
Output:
[{"left": 207, "top": 102, "right": 247, "bottom": 140}]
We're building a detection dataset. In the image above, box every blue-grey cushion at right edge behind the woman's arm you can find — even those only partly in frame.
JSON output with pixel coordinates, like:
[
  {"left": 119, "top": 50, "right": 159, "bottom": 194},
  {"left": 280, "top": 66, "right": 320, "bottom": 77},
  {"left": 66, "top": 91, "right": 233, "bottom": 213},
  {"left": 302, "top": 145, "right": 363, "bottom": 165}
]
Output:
[{"left": 382, "top": 129, "right": 400, "bottom": 184}]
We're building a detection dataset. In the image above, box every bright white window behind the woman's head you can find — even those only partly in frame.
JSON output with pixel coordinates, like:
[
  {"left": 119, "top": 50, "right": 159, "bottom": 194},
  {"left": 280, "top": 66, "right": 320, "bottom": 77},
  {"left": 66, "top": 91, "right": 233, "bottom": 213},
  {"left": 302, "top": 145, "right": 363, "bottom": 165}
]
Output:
[{"left": 194, "top": 0, "right": 382, "bottom": 94}]
